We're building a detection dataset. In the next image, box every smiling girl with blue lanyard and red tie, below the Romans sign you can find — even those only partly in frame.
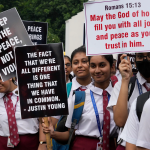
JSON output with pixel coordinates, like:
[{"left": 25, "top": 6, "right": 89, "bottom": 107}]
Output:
[{"left": 66, "top": 55, "right": 116, "bottom": 150}]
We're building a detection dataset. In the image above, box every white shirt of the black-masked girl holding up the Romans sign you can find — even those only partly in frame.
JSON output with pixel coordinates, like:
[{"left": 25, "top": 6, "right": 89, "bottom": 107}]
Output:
[{"left": 107, "top": 72, "right": 147, "bottom": 146}]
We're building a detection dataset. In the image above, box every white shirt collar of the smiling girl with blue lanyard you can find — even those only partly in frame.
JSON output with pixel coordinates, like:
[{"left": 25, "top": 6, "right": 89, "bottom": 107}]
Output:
[{"left": 89, "top": 82, "right": 113, "bottom": 95}]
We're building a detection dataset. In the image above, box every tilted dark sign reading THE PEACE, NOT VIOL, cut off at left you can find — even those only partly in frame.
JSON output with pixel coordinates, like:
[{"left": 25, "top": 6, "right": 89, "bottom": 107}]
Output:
[{"left": 0, "top": 8, "right": 32, "bottom": 81}]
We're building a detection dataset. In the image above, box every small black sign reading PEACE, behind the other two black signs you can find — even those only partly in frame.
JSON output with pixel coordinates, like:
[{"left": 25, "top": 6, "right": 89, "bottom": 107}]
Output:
[{"left": 23, "top": 20, "right": 48, "bottom": 45}]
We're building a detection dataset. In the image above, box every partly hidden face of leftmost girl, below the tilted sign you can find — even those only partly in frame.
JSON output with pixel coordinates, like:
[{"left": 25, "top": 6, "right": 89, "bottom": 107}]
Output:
[{"left": 0, "top": 77, "right": 12, "bottom": 93}]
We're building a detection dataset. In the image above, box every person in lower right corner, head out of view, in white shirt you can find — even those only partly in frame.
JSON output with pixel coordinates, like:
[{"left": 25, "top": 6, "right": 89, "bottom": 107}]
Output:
[{"left": 120, "top": 92, "right": 150, "bottom": 150}]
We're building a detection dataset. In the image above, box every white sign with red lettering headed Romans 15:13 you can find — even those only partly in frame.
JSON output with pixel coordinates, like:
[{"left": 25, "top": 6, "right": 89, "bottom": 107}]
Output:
[{"left": 84, "top": 0, "right": 150, "bottom": 55}]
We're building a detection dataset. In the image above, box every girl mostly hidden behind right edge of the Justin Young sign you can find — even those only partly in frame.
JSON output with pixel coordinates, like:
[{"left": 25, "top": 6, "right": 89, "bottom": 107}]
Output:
[{"left": 64, "top": 55, "right": 73, "bottom": 83}]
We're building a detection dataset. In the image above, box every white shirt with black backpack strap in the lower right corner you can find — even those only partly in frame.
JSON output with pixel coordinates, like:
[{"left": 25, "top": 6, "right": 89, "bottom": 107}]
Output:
[{"left": 120, "top": 83, "right": 150, "bottom": 149}]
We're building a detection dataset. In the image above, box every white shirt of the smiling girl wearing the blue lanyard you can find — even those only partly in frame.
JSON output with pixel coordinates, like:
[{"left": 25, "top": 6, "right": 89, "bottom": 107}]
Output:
[{"left": 65, "top": 83, "right": 116, "bottom": 138}]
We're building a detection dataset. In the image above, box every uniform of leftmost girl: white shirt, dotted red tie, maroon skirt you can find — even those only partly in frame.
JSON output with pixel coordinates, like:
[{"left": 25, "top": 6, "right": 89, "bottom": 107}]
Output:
[{"left": 0, "top": 89, "right": 39, "bottom": 150}]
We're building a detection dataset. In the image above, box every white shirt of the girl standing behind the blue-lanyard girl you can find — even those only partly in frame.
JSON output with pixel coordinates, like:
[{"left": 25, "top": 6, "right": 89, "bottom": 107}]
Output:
[{"left": 52, "top": 77, "right": 92, "bottom": 120}]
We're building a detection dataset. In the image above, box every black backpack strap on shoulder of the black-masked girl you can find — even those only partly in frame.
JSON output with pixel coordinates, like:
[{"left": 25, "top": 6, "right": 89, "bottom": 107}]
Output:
[{"left": 128, "top": 76, "right": 136, "bottom": 101}]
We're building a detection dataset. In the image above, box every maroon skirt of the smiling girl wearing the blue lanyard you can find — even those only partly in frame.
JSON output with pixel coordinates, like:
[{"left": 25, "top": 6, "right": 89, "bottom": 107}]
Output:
[{"left": 71, "top": 136, "right": 116, "bottom": 150}]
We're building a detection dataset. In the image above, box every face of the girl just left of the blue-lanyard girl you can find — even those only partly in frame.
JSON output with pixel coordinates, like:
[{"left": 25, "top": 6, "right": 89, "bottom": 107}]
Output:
[{"left": 72, "top": 52, "right": 90, "bottom": 78}]
